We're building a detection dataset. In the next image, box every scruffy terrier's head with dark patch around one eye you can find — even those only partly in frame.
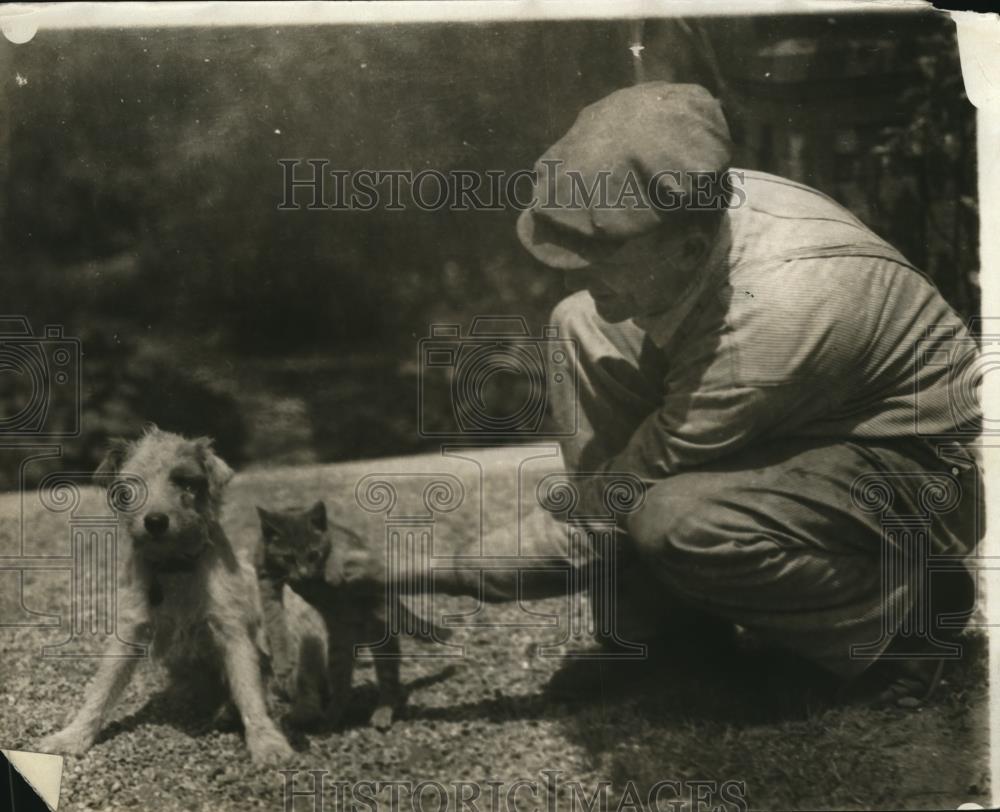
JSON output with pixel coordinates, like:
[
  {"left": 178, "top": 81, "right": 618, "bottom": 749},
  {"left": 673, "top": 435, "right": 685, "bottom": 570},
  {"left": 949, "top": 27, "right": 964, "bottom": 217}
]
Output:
[{"left": 94, "top": 427, "right": 233, "bottom": 566}]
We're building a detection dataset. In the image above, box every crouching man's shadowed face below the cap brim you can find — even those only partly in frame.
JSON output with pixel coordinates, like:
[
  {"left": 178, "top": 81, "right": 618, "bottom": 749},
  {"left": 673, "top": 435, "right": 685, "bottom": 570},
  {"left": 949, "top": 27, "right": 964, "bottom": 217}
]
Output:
[{"left": 565, "top": 232, "right": 708, "bottom": 322}]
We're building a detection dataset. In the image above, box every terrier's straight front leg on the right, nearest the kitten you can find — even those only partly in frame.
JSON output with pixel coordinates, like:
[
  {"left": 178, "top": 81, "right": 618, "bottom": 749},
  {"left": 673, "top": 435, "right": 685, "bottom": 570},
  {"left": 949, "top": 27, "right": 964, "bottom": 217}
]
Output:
[{"left": 215, "top": 624, "right": 295, "bottom": 764}]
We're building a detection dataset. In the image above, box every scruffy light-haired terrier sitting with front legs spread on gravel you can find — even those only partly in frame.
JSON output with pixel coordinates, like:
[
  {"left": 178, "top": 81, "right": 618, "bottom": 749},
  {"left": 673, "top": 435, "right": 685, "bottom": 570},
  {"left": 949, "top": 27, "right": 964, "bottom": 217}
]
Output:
[{"left": 39, "top": 427, "right": 293, "bottom": 763}]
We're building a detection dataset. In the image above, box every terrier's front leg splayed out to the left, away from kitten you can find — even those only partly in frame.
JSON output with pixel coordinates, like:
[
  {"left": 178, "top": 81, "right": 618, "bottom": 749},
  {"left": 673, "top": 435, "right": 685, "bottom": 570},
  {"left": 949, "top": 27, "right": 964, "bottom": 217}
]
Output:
[{"left": 38, "top": 625, "right": 146, "bottom": 756}]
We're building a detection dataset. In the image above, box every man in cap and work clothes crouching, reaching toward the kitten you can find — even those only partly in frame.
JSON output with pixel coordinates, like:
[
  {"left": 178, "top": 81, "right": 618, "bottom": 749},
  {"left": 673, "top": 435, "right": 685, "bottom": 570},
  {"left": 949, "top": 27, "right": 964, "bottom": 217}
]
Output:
[{"left": 348, "top": 82, "right": 982, "bottom": 704}]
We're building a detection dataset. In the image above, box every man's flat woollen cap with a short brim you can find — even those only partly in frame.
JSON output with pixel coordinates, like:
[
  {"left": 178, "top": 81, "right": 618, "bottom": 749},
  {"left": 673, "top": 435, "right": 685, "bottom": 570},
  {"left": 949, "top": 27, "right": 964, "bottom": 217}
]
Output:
[{"left": 517, "top": 82, "right": 732, "bottom": 270}]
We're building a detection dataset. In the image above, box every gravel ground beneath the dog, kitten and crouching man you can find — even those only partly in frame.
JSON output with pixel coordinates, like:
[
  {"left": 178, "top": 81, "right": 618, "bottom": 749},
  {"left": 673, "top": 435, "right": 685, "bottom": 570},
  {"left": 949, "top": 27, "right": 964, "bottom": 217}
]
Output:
[{"left": 0, "top": 450, "right": 989, "bottom": 812}]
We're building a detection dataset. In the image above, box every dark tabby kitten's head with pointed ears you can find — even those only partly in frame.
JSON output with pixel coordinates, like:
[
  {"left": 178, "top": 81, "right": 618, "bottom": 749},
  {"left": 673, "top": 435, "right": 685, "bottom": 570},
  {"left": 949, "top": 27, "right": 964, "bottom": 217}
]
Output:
[{"left": 257, "top": 502, "right": 331, "bottom": 581}]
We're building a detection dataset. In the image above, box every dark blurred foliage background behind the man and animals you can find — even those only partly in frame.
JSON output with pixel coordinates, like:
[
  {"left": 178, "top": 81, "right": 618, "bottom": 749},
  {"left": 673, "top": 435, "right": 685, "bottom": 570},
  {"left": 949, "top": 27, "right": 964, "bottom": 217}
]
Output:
[{"left": 0, "top": 12, "right": 978, "bottom": 488}]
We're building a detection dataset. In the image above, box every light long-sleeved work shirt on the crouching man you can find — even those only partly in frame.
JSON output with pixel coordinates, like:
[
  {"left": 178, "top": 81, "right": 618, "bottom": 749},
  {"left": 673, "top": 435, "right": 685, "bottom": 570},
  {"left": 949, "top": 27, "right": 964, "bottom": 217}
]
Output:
[{"left": 602, "top": 170, "right": 979, "bottom": 480}]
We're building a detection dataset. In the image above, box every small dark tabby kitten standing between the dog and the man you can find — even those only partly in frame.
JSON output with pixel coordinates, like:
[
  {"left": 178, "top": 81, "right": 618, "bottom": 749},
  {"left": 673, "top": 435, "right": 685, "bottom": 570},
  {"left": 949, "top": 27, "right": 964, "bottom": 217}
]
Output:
[{"left": 255, "top": 502, "right": 451, "bottom": 730}]
